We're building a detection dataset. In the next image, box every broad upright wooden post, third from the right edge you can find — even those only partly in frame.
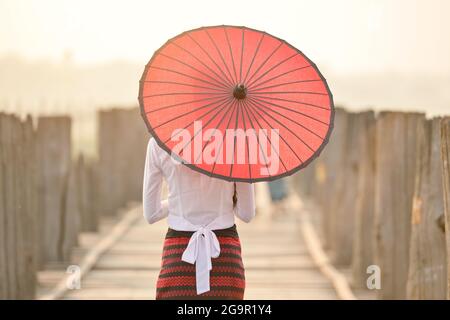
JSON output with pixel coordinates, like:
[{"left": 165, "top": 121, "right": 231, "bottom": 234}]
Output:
[{"left": 375, "top": 112, "right": 424, "bottom": 299}]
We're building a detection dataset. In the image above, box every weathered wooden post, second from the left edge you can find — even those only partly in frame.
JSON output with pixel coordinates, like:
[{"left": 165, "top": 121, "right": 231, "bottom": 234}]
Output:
[{"left": 37, "top": 116, "right": 71, "bottom": 263}]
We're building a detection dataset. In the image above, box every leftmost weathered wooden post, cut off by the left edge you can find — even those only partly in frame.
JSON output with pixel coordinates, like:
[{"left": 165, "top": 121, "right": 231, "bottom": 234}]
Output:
[{"left": 0, "top": 114, "right": 37, "bottom": 299}]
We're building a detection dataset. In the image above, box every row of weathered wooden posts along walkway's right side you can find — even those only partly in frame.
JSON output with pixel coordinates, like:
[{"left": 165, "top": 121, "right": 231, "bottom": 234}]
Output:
[{"left": 294, "top": 109, "right": 450, "bottom": 299}]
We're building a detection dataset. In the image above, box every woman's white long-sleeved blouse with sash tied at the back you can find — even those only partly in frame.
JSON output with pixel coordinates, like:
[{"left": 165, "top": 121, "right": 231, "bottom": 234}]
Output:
[{"left": 143, "top": 138, "right": 255, "bottom": 294}]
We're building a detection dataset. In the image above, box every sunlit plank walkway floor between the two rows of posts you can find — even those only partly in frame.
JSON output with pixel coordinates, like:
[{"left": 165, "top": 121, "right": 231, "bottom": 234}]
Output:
[{"left": 39, "top": 184, "right": 348, "bottom": 299}]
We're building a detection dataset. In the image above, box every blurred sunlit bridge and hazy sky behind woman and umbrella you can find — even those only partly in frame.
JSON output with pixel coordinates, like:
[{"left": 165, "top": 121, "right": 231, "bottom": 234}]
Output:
[{"left": 0, "top": 0, "right": 450, "bottom": 299}]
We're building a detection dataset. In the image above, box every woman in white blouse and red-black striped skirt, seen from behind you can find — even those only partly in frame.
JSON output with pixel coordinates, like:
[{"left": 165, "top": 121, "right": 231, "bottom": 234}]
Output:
[{"left": 143, "top": 138, "right": 255, "bottom": 299}]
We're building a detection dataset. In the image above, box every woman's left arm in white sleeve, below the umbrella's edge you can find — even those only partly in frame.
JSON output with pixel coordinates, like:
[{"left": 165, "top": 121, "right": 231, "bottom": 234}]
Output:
[{"left": 142, "top": 138, "right": 169, "bottom": 223}]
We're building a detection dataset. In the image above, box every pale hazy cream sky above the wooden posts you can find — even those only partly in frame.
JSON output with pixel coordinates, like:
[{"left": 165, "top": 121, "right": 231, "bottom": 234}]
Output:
[{"left": 0, "top": 0, "right": 450, "bottom": 154}]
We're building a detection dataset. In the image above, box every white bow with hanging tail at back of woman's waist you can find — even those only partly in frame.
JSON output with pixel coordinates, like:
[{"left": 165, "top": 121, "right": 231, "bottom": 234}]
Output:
[{"left": 181, "top": 227, "right": 220, "bottom": 294}]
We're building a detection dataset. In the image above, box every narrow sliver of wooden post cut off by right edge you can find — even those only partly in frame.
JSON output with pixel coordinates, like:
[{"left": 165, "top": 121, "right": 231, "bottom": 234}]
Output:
[{"left": 441, "top": 117, "right": 450, "bottom": 299}]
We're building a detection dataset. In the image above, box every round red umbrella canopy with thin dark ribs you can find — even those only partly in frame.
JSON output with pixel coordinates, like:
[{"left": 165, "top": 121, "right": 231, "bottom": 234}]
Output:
[{"left": 139, "top": 26, "right": 334, "bottom": 182}]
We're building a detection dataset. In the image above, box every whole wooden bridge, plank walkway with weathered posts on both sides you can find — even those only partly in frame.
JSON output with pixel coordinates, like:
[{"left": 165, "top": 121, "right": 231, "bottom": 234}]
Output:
[{"left": 0, "top": 109, "right": 450, "bottom": 299}]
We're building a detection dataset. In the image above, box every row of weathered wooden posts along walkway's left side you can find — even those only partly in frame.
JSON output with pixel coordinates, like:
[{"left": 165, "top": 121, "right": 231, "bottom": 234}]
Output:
[{"left": 0, "top": 108, "right": 148, "bottom": 299}]
